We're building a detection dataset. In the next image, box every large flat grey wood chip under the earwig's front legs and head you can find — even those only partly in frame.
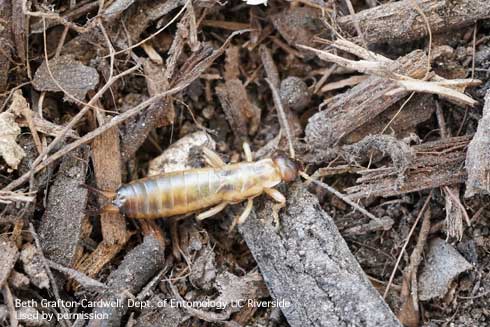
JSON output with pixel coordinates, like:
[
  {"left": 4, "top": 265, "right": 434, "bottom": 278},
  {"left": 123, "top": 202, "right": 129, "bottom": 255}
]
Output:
[{"left": 239, "top": 183, "right": 401, "bottom": 327}]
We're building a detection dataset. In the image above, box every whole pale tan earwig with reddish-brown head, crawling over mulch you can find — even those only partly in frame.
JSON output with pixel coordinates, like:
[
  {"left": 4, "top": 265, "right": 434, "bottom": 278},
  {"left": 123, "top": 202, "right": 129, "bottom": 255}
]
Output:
[{"left": 103, "top": 145, "right": 298, "bottom": 223}]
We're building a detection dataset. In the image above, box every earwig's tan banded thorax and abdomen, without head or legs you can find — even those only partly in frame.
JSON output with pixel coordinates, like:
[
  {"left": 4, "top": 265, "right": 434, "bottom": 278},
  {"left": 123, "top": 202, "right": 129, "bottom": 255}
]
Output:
[{"left": 115, "top": 162, "right": 275, "bottom": 219}]
